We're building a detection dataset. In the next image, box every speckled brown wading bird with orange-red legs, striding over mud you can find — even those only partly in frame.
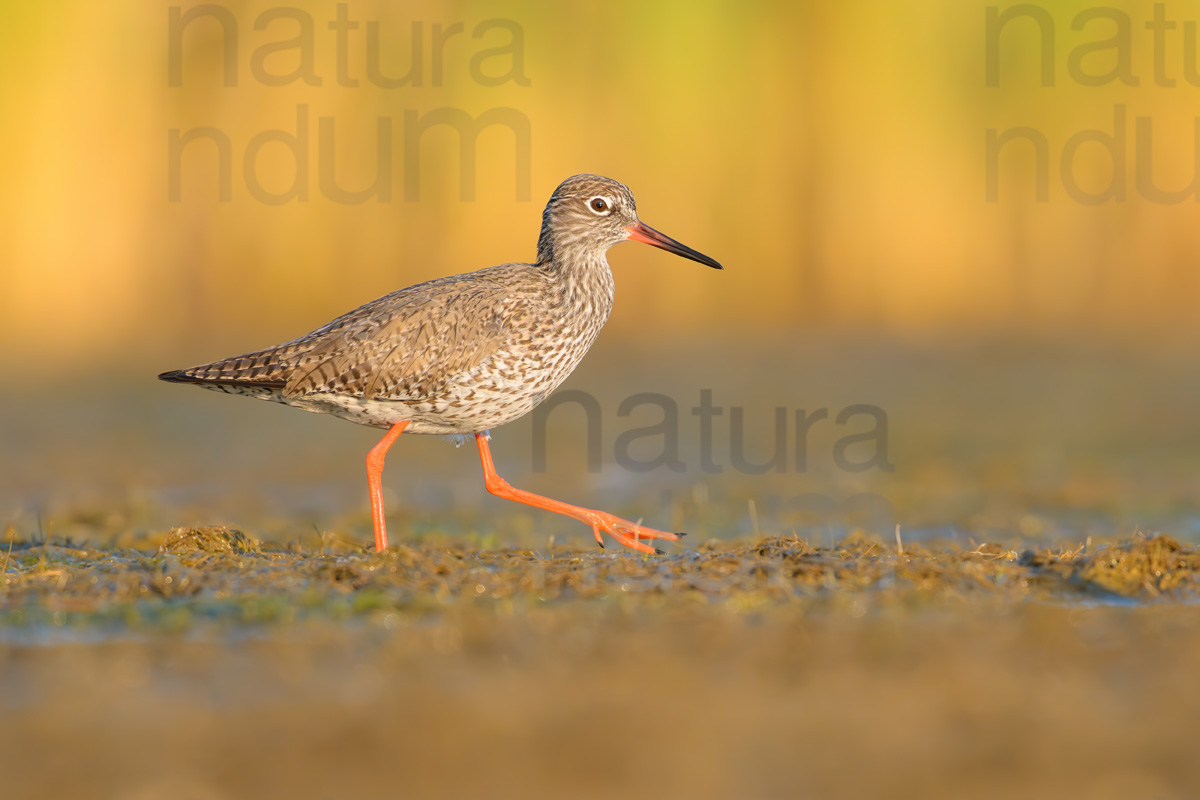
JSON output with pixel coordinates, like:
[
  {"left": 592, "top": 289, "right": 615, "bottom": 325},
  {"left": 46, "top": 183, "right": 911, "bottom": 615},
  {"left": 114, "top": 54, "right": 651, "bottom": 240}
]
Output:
[{"left": 158, "top": 175, "right": 722, "bottom": 553}]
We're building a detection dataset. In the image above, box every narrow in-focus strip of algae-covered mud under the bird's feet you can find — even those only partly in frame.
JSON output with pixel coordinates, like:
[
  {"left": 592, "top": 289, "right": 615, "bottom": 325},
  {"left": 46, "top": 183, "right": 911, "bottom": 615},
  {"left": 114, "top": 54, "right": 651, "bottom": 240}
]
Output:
[{"left": 0, "top": 527, "right": 1200, "bottom": 631}]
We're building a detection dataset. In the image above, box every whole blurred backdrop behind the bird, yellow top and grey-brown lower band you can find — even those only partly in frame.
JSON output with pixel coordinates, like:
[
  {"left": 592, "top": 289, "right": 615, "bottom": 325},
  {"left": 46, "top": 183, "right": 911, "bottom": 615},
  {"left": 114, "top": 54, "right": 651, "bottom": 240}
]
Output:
[{"left": 0, "top": 0, "right": 1200, "bottom": 541}]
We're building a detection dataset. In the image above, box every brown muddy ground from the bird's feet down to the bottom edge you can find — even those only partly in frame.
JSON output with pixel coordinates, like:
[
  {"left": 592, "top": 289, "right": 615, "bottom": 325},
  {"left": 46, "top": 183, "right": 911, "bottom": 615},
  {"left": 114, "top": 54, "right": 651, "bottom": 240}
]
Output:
[{"left": 0, "top": 528, "right": 1200, "bottom": 800}]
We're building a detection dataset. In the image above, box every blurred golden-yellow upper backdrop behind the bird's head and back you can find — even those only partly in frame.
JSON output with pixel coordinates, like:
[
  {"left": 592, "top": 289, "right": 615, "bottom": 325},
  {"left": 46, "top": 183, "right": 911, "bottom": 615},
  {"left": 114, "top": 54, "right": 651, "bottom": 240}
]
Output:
[{"left": 0, "top": 0, "right": 1200, "bottom": 374}]
